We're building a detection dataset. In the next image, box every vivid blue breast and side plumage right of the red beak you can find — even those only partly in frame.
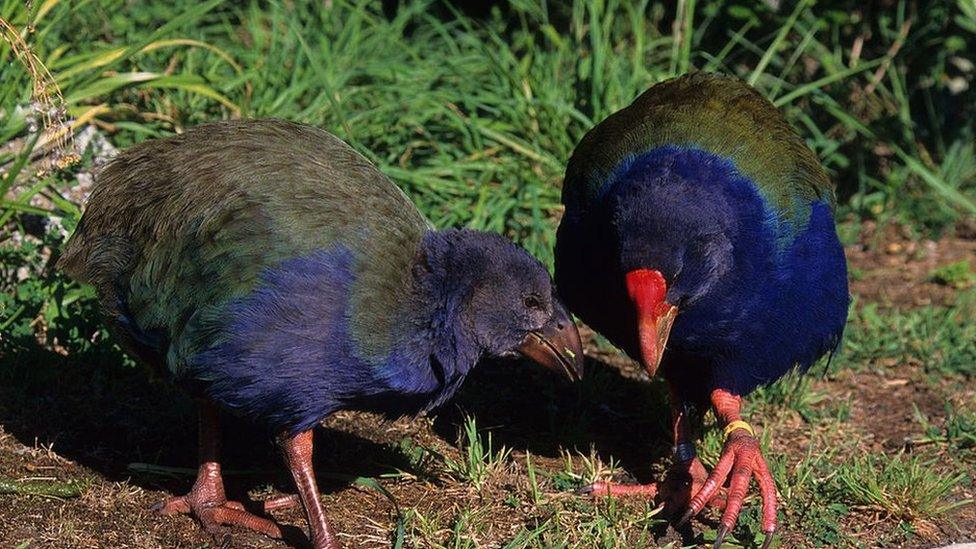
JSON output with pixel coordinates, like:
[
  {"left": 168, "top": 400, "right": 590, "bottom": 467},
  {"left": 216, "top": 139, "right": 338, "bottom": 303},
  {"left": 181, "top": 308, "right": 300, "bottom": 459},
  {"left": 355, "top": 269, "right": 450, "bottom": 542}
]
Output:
[{"left": 665, "top": 198, "right": 849, "bottom": 395}]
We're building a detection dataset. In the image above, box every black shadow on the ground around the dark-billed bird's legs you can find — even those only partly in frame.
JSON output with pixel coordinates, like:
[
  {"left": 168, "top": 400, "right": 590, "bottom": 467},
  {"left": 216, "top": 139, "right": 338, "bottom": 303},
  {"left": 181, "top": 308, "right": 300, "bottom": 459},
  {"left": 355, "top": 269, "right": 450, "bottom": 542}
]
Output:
[{"left": 0, "top": 342, "right": 408, "bottom": 499}]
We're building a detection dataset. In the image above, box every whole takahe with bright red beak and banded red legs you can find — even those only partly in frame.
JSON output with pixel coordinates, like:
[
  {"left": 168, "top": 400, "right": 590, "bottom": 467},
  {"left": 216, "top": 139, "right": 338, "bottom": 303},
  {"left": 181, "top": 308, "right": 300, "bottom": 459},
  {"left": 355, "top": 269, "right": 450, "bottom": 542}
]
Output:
[{"left": 556, "top": 73, "right": 849, "bottom": 546}]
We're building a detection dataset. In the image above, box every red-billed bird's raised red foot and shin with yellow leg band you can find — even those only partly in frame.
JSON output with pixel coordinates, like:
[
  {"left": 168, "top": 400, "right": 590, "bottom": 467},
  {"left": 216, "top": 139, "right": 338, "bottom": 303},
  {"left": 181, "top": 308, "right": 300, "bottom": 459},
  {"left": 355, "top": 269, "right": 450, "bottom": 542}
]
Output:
[{"left": 679, "top": 389, "right": 776, "bottom": 548}]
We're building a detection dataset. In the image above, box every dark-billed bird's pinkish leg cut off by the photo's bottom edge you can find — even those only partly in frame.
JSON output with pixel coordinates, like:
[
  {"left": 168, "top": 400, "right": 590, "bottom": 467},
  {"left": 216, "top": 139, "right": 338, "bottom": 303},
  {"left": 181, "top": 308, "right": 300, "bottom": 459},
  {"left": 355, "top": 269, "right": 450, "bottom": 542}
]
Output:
[{"left": 279, "top": 429, "right": 339, "bottom": 549}]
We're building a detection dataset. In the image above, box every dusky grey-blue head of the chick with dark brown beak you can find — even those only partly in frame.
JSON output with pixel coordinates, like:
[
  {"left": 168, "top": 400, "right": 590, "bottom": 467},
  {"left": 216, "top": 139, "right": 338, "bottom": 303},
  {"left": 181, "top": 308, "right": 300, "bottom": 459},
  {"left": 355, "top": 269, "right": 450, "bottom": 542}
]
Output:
[{"left": 418, "top": 229, "right": 583, "bottom": 380}]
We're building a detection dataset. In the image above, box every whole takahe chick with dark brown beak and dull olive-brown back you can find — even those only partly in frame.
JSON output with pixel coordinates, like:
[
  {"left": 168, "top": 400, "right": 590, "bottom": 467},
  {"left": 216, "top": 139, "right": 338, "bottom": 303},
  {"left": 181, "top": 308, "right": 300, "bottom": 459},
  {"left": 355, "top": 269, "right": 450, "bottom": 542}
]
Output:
[{"left": 59, "top": 120, "right": 583, "bottom": 548}]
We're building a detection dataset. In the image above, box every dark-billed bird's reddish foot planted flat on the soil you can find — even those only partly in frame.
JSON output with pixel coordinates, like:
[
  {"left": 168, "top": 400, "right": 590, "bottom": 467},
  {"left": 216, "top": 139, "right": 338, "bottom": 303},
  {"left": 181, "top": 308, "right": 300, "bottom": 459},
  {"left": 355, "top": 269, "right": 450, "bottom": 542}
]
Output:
[{"left": 153, "top": 462, "right": 282, "bottom": 539}]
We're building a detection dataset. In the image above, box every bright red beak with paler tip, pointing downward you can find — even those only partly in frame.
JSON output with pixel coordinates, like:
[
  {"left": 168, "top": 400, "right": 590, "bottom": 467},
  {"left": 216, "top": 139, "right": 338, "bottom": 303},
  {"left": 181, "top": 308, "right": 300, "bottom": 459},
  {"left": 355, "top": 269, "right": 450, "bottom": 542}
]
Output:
[{"left": 626, "top": 269, "right": 678, "bottom": 377}]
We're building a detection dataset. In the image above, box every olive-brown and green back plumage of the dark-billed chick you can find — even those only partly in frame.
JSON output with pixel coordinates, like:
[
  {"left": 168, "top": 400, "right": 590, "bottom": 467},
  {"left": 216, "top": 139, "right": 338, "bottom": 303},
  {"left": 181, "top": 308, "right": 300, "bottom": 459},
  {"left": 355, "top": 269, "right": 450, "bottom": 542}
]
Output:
[{"left": 59, "top": 120, "right": 430, "bottom": 368}]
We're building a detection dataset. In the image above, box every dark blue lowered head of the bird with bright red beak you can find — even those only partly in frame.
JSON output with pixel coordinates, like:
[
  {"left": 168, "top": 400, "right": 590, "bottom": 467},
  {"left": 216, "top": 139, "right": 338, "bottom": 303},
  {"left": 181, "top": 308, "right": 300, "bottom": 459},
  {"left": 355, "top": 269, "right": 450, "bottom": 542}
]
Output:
[{"left": 614, "top": 163, "right": 736, "bottom": 376}]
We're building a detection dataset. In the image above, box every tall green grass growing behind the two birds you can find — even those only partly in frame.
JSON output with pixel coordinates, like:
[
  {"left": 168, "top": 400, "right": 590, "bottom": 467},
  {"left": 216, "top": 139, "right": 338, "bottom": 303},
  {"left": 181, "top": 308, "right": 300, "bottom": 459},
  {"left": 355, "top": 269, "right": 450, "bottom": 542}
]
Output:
[{"left": 0, "top": 0, "right": 976, "bottom": 259}]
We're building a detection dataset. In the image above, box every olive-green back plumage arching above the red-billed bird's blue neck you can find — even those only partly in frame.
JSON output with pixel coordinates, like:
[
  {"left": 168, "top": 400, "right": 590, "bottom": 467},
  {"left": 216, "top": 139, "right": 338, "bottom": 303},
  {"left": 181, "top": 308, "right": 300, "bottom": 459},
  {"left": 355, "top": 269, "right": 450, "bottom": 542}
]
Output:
[{"left": 563, "top": 72, "right": 834, "bottom": 225}]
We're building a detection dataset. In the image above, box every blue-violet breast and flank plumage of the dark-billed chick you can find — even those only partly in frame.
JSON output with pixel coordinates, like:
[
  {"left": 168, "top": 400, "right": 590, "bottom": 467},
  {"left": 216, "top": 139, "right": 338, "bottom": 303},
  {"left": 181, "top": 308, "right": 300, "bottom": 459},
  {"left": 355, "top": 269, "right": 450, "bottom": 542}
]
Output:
[{"left": 184, "top": 247, "right": 463, "bottom": 433}]
